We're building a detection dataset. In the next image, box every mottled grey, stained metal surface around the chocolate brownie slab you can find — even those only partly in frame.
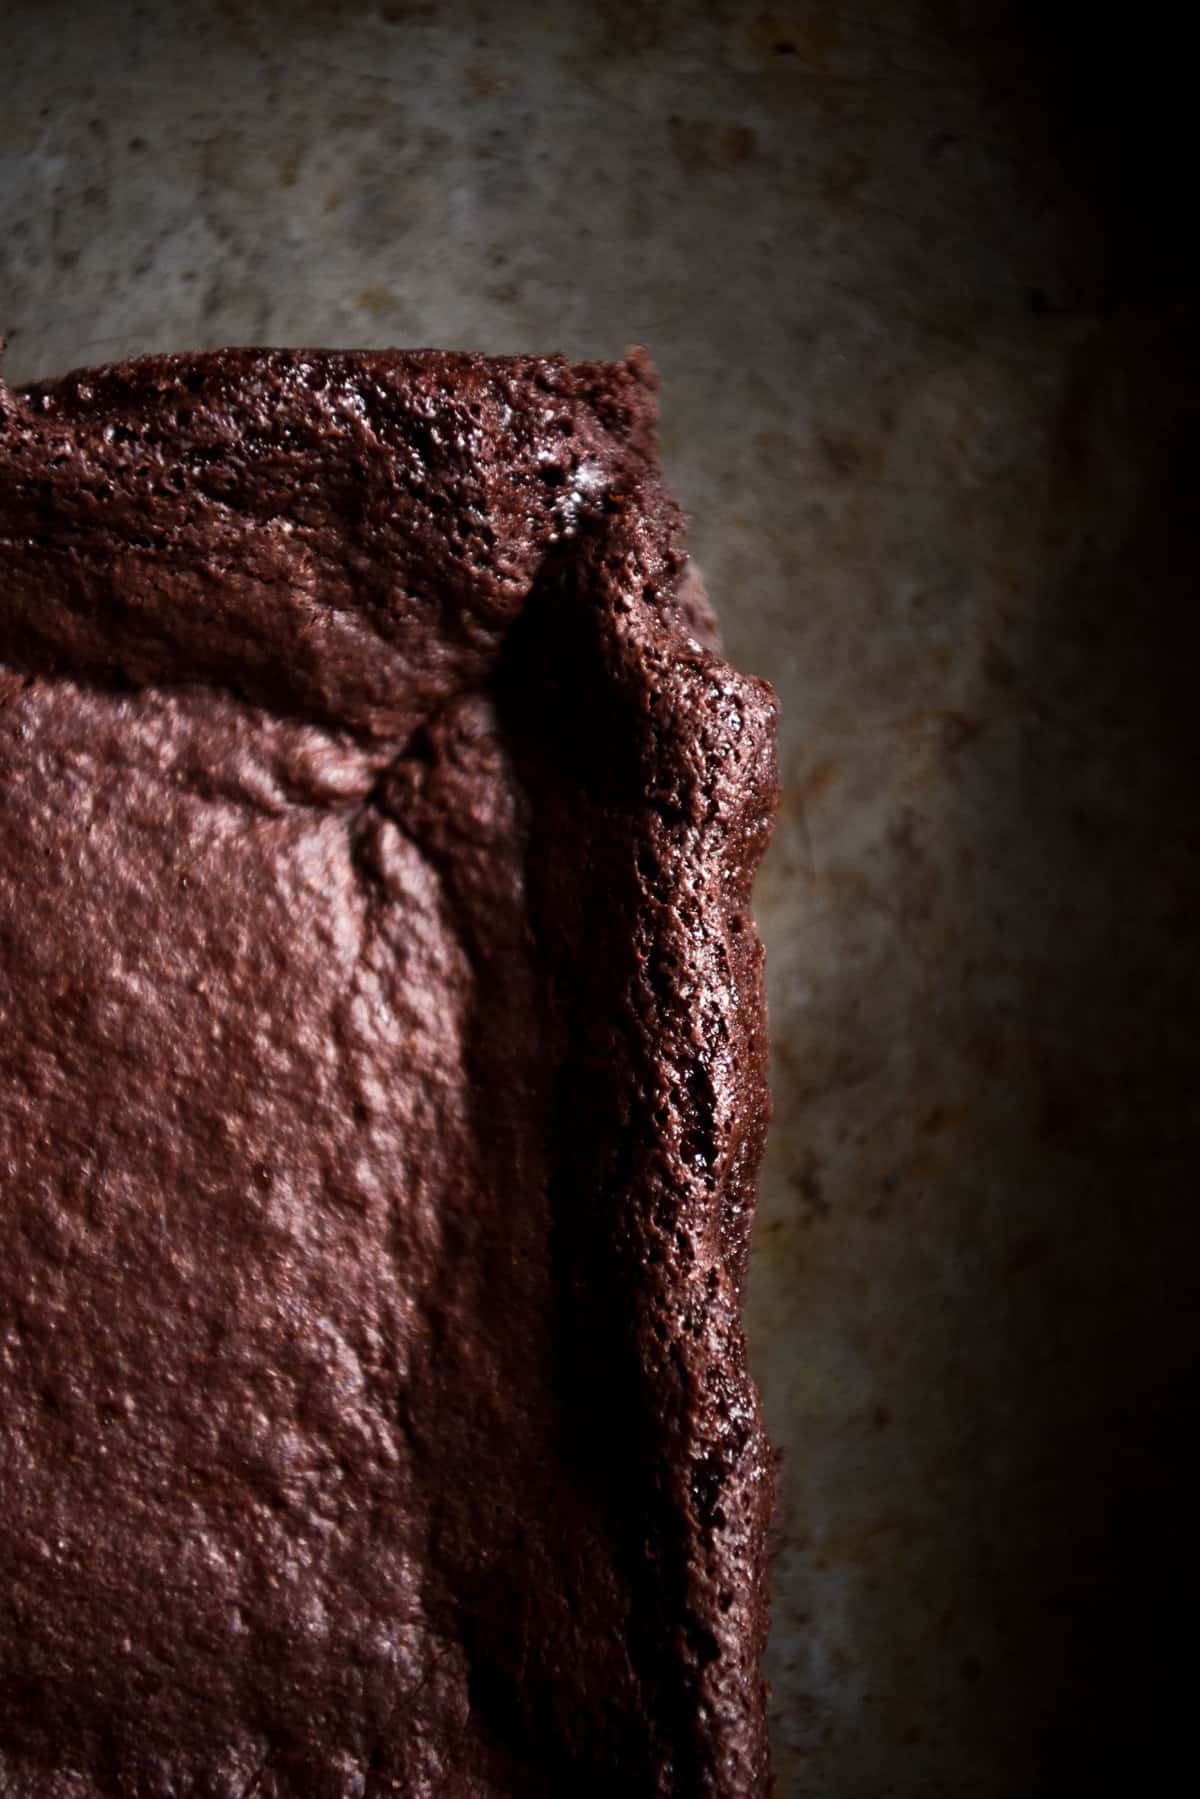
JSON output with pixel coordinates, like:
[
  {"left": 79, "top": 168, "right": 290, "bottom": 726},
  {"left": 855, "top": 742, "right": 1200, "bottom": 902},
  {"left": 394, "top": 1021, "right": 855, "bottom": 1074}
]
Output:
[{"left": 0, "top": 0, "right": 1200, "bottom": 1799}]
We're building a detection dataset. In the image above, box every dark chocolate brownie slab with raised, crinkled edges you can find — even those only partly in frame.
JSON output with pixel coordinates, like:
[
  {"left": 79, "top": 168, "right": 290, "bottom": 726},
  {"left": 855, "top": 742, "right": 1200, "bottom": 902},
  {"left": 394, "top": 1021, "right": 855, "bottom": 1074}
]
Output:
[{"left": 0, "top": 351, "right": 775, "bottom": 1799}]
